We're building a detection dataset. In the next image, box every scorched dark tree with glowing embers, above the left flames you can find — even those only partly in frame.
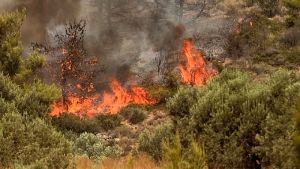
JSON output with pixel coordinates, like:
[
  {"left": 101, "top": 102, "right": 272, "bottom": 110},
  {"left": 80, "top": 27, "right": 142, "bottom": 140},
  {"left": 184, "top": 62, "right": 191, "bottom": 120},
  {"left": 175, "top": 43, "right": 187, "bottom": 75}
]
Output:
[{"left": 33, "top": 20, "right": 97, "bottom": 110}]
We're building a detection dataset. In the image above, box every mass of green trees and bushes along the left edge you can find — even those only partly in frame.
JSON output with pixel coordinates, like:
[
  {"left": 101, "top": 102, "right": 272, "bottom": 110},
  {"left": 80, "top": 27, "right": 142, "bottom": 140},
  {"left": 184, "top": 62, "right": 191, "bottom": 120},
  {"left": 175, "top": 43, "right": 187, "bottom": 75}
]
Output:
[{"left": 0, "top": 12, "right": 71, "bottom": 169}]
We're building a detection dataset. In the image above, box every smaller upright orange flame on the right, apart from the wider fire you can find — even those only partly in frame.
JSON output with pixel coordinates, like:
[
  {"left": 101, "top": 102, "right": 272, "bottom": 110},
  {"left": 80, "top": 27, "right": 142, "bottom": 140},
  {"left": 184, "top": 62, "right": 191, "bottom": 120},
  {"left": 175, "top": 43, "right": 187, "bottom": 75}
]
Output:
[{"left": 179, "top": 40, "right": 218, "bottom": 86}]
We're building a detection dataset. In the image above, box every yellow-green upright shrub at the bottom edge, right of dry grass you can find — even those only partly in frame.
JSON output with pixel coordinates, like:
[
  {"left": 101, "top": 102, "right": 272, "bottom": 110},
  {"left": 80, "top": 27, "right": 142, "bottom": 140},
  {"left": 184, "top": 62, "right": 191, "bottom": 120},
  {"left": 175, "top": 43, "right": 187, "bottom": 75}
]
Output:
[{"left": 162, "top": 133, "right": 208, "bottom": 169}]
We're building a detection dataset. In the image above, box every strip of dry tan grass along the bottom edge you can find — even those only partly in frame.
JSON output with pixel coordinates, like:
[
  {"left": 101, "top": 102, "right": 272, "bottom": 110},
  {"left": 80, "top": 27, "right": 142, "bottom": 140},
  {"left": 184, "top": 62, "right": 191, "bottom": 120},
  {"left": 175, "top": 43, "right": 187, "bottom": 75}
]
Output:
[{"left": 75, "top": 155, "right": 160, "bottom": 169}]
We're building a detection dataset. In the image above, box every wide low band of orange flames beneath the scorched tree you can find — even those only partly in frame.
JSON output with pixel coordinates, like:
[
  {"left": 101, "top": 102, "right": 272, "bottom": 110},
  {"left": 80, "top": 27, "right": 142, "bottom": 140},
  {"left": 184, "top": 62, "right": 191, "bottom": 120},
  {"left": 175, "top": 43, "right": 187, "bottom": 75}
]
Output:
[{"left": 50, "top": 80, "right": 156, "bottom": 117}]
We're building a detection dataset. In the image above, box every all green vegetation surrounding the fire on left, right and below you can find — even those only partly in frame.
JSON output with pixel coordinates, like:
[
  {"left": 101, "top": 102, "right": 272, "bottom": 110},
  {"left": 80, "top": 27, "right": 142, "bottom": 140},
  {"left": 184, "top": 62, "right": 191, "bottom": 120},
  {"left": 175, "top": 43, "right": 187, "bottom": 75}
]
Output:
[{"left": 0, "top": 0, "right": 300, "bottom": 169}]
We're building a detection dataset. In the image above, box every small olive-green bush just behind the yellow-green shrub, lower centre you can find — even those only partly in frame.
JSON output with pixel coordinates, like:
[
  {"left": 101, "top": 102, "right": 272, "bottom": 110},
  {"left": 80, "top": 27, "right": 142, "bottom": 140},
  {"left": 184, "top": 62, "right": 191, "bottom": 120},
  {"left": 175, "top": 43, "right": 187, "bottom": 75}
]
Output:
[{"left": 138, "top": 122, "right": 174, "bottom": 161}]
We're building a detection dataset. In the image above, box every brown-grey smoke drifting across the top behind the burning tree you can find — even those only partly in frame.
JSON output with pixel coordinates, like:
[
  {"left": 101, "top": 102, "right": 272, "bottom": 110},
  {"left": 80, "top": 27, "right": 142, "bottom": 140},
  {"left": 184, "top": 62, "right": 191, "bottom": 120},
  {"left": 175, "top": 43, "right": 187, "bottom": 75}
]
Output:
[{"left": 0, "top": 0, "right": 232, "bottom": 86}]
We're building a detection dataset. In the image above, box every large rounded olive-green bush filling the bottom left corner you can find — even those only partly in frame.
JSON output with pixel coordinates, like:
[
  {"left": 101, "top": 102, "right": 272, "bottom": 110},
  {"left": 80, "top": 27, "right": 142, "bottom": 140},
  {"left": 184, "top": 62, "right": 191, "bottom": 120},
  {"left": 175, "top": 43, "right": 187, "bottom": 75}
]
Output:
[{"left": 0, "top": 113, "right": 71, "bottom": 169}]
